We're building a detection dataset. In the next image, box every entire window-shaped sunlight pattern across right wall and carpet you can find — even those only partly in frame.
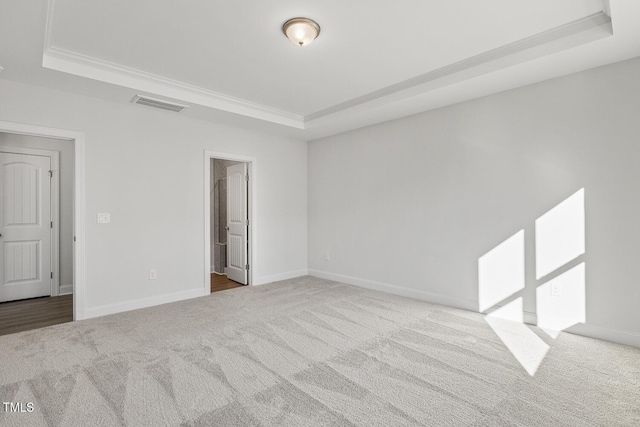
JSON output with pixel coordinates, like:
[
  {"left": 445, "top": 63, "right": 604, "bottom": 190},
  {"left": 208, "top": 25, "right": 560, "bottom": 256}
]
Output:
[{"left": 478, "top": 188, "right": 586, "bottom": 376}]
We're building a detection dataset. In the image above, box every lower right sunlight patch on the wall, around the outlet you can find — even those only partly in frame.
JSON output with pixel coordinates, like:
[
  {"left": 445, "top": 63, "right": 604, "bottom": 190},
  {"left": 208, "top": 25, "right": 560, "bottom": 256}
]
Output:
[{"left": 536, "top": 263, "right": 586, "bottom": 338}]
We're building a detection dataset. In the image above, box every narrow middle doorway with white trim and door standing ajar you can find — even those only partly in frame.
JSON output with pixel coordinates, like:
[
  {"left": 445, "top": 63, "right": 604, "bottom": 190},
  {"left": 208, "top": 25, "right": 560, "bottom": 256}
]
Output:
[{"left": 205, "top": 151, "right": 256, "bottom": 293}]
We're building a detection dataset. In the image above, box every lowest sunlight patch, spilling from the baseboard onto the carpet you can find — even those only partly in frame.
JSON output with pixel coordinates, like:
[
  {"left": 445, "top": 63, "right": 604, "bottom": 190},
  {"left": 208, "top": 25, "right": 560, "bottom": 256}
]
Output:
[{"left": 485, "top": 298, "right": 549, "bottom": 376}]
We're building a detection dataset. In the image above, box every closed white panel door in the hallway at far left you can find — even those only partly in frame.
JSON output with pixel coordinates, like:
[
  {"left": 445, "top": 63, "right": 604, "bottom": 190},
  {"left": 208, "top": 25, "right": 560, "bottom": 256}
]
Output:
[{"left": 0, "top": 153, "right": 51, "bottom": 302}]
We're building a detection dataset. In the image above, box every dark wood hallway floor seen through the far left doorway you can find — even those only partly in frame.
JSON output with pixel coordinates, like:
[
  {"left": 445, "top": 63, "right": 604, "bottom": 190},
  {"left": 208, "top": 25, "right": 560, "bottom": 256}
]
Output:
[{"left": 0, "top": 295, "right": 73, "bottom": 335}]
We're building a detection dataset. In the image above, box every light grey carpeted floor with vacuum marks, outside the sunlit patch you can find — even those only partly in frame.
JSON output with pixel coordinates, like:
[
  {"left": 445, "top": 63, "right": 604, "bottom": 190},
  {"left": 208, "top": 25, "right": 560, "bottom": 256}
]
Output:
[{"left": 0, "top": 277, "right": 640, "bottom": 426}]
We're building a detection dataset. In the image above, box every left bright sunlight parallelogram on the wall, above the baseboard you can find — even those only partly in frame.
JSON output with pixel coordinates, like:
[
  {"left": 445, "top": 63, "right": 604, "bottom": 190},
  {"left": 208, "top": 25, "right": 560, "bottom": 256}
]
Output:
[{"left": 478, "top": 230, "right": 524, "bottom": 312}]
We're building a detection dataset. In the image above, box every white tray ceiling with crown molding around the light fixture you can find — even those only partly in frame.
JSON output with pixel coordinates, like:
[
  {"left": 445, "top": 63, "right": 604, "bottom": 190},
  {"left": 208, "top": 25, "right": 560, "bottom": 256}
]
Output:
[{"left": 0, "top": 0, "right": 640, "bottom": 140}]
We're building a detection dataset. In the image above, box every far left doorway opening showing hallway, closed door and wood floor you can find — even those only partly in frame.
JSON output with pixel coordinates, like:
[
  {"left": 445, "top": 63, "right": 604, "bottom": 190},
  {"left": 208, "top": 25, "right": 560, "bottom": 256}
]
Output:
[{"left": 0, "top": 132, "right": 74, "bottom": 334}]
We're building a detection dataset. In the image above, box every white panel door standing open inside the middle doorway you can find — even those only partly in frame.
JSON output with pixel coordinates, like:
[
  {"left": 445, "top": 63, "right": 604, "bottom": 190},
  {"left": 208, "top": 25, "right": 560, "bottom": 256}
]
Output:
[{"left": 227, "top": 163, "right": 248, "bottom": 285}]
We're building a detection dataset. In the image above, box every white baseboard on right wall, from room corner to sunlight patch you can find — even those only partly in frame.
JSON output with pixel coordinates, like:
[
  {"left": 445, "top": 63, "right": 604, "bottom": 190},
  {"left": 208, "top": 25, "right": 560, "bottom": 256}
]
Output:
[{"left": 309, "top": 269, "right": 478, "bottom": 312}]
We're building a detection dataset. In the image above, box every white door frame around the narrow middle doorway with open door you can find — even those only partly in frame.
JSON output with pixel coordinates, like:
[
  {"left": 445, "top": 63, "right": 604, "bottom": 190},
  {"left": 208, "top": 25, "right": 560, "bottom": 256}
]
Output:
[{"left": 203, "top": 150, "right": 258, "bottom": 295}]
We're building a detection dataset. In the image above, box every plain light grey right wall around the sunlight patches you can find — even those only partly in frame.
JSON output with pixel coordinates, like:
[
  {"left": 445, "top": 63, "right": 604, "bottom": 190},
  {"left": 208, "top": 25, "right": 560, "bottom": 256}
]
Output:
[{"left": 308, "top": 55, "right": 640, "bottom": 345}]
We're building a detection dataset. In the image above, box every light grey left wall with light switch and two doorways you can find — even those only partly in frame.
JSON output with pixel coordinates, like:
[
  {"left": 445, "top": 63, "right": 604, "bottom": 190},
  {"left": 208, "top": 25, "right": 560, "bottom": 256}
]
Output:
[{"left": 0, "top": 80, "right": 307, "bottom": 316}]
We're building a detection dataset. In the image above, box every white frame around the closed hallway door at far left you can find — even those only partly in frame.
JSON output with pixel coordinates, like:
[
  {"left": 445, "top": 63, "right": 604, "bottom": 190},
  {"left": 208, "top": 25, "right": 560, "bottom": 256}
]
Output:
[{"left": 0, "top": 145, "right": 60, "bottom": 297}]
